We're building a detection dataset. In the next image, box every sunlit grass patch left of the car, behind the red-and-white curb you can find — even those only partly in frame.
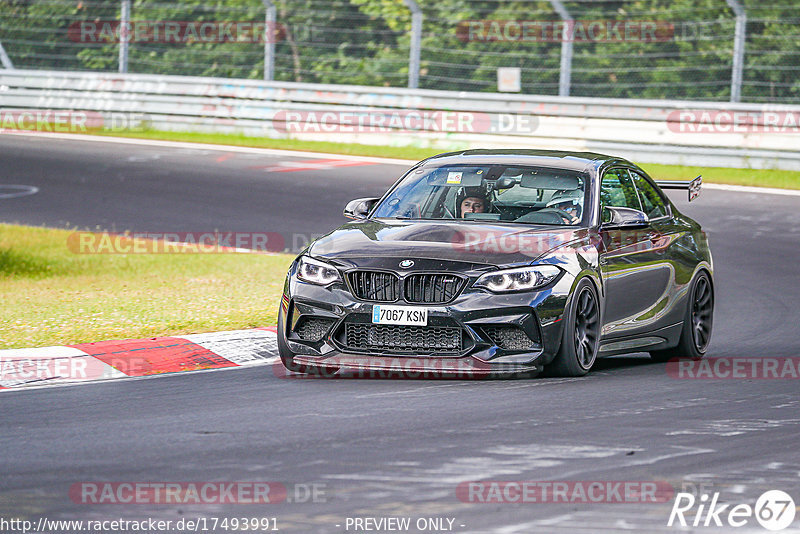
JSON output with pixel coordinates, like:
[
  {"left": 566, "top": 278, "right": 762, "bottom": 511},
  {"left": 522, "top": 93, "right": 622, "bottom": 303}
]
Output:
[{"left": 0, "top": 224, "right": 293, "bottom": 349}]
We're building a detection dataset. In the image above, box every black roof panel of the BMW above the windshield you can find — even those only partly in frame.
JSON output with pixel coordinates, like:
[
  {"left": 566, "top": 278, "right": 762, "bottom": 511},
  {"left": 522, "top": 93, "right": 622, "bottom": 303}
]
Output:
[{"left": 420, "top": 148, "right": 635, "bottom": 172}]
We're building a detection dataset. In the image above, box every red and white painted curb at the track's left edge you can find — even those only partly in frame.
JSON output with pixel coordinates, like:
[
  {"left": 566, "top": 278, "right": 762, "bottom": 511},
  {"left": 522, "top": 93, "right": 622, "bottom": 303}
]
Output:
[{"left": 0, "top": 327, "right": 278, "bottom": 390}]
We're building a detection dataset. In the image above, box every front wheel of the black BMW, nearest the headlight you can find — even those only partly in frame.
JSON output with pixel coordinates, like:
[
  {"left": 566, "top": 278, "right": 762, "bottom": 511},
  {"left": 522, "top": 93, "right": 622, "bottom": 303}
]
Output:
[{"left": 545, "top": 278, "right": 601, "bottom": 376}]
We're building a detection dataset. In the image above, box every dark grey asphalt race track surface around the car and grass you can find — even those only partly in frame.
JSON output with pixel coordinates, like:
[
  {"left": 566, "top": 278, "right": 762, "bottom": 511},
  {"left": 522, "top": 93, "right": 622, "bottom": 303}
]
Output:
[{"left": 0, "top": 136, "right": 800, "bottom": 533}]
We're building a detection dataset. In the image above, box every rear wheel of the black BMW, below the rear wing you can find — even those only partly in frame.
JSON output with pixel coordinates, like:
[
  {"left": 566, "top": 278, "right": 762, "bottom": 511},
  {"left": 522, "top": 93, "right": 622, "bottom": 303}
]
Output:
[{"left": 650, "top": 271, "right": 714, "bottom": 362}]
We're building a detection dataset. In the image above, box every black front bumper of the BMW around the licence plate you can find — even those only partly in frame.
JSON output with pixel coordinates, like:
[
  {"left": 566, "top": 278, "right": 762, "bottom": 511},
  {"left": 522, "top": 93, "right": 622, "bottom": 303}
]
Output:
[{"left": 278, "top": 264, "right": 570, "bottom": 377}]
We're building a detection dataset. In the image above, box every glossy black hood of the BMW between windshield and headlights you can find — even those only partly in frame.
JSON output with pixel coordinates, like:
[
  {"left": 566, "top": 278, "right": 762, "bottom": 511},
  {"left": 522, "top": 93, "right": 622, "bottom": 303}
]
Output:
[{"left": 307, "top": 219, "right": 588, "bottom": 268}]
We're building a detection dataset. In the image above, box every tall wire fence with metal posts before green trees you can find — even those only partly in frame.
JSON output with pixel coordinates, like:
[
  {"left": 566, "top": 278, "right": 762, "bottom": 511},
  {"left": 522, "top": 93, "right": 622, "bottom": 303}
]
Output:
[{"left": 0, "top": 0, "right": 800, "bottom": 103}]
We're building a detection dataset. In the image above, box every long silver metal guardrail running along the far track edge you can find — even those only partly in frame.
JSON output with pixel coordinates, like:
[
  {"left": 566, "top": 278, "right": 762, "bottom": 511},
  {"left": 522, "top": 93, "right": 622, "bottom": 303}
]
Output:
[{"left": 0, "top": 69, "right": 800, "bottom": 170}]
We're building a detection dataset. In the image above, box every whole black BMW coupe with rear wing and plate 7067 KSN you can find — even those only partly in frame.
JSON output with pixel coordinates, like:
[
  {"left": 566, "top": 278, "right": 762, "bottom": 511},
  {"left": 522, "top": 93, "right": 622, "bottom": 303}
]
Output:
[{"left": 278, "top": 150, "right": 714, "bottom": 376}]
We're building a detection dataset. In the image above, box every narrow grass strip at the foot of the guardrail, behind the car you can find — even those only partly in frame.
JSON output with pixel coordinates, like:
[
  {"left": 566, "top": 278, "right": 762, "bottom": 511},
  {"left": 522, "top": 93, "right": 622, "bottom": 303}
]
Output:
[{"left": 100, "top": 131, "right": 800, "bottom": 189}]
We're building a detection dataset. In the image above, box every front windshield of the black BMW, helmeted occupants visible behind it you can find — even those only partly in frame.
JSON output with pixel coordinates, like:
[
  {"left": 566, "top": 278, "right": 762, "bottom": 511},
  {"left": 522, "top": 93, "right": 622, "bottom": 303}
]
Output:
[{"left": 372, "top": 165, "right": 588, "bottom": 226}]
